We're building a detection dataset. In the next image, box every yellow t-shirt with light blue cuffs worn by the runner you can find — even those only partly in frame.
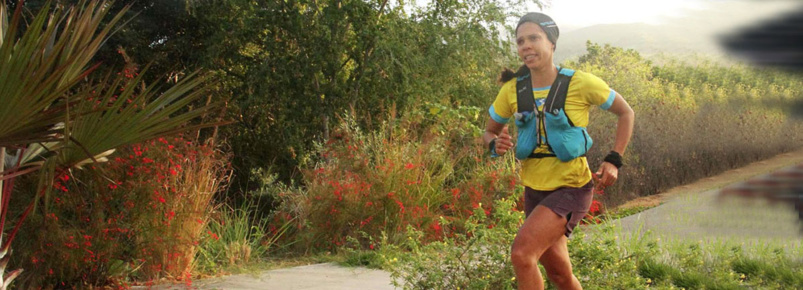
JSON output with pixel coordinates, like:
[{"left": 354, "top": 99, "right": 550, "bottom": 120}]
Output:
[{"left": 489, "top": 71, "right": 616, "bottom": 191}]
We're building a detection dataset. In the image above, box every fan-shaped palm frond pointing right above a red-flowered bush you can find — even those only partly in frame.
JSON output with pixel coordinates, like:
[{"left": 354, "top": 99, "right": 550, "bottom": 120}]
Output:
[{"left": 57, "top": 66, "right": 226, "bottom": 168}]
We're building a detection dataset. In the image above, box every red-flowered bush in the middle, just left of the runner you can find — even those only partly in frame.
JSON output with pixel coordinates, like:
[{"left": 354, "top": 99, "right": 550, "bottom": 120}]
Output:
[{"left": 276, "top": 108, "right": 516, "bottom": 249}]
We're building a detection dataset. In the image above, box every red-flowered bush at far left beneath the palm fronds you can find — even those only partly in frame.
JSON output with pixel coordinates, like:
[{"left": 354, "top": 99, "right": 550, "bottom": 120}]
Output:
[{"left": 13, "top": 137, "right": 227, "bottom": 287}]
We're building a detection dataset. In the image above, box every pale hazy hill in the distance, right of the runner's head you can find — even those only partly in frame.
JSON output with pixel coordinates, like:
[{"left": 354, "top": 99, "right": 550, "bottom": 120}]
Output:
[{"left": 555, "top": 1, "right": 801, "bottom": 63}]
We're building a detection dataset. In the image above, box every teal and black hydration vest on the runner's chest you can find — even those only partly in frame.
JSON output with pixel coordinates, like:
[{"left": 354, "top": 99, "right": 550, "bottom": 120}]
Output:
[{"left": 514, "top": 68, "right": 594, "bottom": 162}]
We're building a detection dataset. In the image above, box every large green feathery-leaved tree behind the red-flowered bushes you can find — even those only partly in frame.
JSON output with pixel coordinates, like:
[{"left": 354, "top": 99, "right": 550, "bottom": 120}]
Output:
[{"left": 188, "top": 0, "right": 536, "bottom": 194}]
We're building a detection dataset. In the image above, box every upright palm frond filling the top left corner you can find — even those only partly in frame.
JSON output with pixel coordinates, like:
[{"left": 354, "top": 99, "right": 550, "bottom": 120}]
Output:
[{"left": 0, "top": 1, "right": 126, "bottom": 147}]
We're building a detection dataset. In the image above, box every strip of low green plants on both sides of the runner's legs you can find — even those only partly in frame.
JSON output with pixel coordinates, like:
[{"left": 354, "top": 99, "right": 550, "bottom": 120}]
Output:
[{"left": 386, "top": 214, "right": 803, "bottom": 289}]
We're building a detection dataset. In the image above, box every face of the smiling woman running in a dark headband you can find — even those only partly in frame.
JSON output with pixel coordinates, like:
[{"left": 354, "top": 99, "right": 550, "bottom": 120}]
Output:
[{"left": 516, "top": 22, "right": 555, "bottom": 69}]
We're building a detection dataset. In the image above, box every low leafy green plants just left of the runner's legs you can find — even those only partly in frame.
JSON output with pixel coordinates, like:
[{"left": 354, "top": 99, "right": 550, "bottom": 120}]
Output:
[{"left": 379, "top": 198, "right": 523, "bottom": 289}]
